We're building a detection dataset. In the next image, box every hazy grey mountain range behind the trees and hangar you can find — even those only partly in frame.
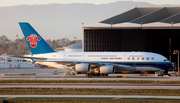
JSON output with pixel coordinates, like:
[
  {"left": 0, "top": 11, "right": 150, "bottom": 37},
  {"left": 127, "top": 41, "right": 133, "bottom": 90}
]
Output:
[{"left": 0, "top": 1, "right": 177, "bottom": 40}]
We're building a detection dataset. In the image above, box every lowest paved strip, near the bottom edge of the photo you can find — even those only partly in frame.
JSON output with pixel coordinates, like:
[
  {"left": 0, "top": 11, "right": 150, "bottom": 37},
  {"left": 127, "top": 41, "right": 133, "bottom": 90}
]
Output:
[{"left": 0, "top": 95, "right": 180, "bottom": 101}]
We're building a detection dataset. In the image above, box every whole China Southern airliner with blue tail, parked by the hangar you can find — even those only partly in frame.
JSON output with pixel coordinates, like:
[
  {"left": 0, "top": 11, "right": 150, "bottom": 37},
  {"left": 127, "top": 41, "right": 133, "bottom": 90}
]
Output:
[{"left": 16, "top": 22, "right": 173, "bottom": 76}]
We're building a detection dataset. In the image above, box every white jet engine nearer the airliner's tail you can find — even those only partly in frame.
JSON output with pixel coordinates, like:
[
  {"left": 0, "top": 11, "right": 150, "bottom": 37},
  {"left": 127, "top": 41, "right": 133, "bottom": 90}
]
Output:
[{"left": 75, "top": 63, "right": 91, "bottom": 72}]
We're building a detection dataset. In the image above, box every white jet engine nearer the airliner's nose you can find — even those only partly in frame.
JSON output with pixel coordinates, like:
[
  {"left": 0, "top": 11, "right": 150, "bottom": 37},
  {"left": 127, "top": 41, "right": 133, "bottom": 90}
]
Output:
[{"left": 100, "top": 65, "right": 115, "bottom": 74}]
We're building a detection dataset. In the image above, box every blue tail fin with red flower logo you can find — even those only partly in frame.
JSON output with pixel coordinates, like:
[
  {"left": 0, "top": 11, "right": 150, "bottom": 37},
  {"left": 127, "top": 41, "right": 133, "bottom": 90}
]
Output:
[{"left": 19, "top": 22, "right": 55, "bottom": 54}]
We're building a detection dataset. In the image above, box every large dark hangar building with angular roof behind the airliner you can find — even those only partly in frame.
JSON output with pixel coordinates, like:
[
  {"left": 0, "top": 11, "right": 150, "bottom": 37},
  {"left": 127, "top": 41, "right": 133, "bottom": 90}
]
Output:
[{"left": 82, "top": 7, "right": 180, "bottom": 62}]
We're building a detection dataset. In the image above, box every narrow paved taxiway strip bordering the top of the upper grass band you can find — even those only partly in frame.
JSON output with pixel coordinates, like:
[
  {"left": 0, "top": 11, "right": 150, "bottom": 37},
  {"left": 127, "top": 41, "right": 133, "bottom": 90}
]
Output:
[{"left": 0, "top": 75, "right": 180, "bottom": 81}]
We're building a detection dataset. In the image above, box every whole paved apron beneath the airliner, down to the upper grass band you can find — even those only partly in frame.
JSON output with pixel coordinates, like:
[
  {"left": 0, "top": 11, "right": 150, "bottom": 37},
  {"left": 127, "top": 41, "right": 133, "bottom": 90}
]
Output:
[{"left": 0, "top": 69, "right": 180, "bottom": 81}]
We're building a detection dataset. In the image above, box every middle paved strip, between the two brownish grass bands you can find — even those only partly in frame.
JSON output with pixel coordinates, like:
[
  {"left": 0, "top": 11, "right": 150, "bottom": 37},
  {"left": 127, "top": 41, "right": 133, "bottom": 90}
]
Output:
[{"left": 0, "top": 83, "right": 180, "bottom": 89}]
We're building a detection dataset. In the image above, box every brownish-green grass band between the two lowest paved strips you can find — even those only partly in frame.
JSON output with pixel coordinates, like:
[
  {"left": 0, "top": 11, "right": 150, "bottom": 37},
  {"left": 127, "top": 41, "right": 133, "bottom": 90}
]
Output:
[{"left": 0, "top": 88, "right": 180, "bottom": 96}]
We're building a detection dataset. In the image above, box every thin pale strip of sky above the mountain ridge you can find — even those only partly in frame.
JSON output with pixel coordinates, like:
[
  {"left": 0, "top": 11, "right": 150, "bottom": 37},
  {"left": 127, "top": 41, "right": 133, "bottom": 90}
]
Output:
[{"left": 0, "top": 0, "right": 180, "bottom": 7}]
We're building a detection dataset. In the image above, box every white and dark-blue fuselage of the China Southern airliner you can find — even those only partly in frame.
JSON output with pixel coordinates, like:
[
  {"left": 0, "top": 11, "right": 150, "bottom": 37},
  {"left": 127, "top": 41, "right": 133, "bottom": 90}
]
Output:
[{"left": 26, "top": 52, "right": 172, "bottom": 71}]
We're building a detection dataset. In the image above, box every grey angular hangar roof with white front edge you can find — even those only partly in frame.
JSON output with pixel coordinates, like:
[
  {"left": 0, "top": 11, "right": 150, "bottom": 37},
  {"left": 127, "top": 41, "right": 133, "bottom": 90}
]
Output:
[{"left": 83, "top": 7, "right": 180, "bottom": 29}]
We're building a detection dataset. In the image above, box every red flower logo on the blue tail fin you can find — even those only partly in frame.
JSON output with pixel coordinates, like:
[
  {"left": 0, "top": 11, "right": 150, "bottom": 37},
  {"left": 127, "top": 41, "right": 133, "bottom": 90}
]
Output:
[{"left": 27, "top": 34, "right": 41, "bottom": 48}]
